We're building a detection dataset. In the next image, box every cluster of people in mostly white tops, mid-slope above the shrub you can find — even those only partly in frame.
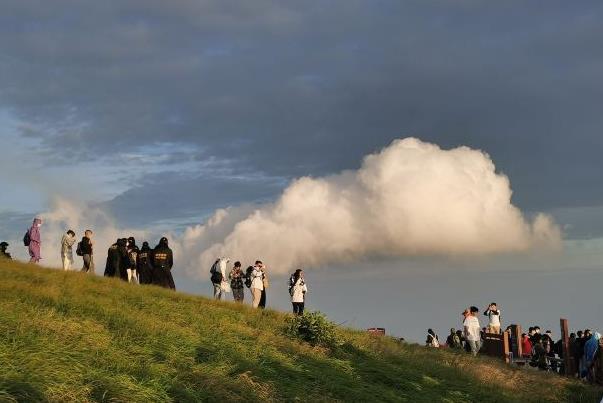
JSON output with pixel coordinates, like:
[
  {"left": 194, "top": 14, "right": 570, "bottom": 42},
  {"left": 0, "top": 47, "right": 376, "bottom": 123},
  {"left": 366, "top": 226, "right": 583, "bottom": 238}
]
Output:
[{"left": 209, "top": 257, "right": 308, "bottom": 315}]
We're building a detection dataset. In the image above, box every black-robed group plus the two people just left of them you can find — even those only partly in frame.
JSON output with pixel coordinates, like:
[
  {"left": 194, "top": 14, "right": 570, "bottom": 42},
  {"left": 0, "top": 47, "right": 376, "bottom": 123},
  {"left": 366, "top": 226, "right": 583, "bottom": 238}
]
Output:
[{"left": 61, "top": 230, "right": 176, "bottom": 290}]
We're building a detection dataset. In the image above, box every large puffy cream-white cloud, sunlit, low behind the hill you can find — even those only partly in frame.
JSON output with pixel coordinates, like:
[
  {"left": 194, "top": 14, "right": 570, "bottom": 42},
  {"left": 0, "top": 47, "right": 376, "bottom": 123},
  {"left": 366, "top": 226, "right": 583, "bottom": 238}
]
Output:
[{"left": 178, "top": 138, "right": 561, "bottom": 276}]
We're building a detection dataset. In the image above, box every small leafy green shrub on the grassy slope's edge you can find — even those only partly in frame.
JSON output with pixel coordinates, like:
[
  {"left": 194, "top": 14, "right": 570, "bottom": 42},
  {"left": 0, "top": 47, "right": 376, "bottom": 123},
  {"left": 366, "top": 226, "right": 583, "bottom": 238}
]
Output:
[{"left": 286, "top": 312, "right": 343, "bottom": 348}]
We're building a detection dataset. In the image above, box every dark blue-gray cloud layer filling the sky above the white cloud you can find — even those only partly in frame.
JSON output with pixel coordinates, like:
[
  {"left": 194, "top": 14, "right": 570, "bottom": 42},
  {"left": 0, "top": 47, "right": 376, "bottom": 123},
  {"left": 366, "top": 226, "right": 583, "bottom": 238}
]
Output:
[{"left": 0, "top": 0, "right": 603, "bottom": 213}]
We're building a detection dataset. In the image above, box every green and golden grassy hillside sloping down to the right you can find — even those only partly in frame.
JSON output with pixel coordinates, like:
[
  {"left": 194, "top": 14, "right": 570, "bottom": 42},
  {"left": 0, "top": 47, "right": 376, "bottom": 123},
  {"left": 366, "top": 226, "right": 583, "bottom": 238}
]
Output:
[{"left": 0, "top": 260, "right": 602, "bottom": 402}]
